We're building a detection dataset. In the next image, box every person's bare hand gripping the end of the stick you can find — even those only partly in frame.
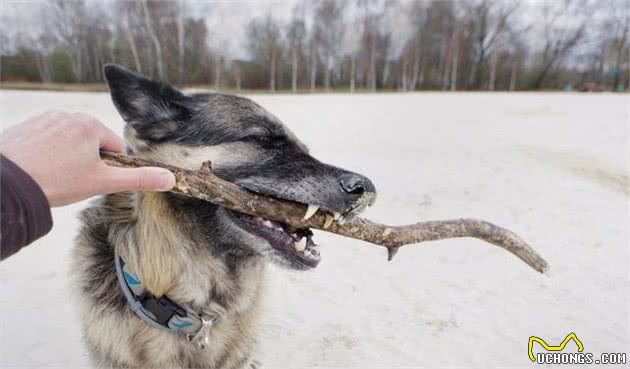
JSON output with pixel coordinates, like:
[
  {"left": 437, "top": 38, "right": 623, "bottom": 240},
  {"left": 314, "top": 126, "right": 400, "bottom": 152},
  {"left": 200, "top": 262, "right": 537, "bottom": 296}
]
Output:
[{"left": 0, "top": 112, "right": 175, "bottom": 207}]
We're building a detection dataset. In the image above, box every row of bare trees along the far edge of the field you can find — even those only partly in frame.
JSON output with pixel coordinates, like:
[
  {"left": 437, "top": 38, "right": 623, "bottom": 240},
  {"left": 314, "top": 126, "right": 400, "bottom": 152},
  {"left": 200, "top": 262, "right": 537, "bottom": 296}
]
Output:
[{"left": 0, "top": 0, "right": 630, "bottom": 91}]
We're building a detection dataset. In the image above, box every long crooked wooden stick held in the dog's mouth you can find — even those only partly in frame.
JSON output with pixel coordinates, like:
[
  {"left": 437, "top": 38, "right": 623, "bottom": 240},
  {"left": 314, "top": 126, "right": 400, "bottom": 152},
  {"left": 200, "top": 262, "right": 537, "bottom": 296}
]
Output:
[{"left": 101, "top": 152, "right": 547, "bottom": 273}]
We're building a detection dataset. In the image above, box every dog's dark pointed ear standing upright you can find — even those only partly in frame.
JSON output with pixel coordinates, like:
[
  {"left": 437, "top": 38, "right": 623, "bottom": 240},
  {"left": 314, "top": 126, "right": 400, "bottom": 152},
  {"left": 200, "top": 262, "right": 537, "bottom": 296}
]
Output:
[{"left": 103, "top": 64, "right": 192, "bottom": 142}]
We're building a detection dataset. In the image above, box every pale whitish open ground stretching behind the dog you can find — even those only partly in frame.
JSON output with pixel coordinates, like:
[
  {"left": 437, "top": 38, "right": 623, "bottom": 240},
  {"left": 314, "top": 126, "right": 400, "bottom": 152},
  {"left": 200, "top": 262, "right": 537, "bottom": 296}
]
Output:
[{"left": 0, "top": 91, "right": 630, "bottom": 368}]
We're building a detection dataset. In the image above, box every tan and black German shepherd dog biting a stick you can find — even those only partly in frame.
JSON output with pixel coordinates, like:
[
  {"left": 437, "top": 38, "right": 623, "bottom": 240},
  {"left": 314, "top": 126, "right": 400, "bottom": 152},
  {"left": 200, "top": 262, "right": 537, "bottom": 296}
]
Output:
[{"left": 73, "top": 64, "right": 376, "bottom": 368}]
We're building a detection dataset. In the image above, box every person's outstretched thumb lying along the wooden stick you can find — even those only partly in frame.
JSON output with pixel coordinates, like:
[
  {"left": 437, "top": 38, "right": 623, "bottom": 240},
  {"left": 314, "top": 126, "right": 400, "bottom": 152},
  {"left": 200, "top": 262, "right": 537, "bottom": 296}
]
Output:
[{"left": 103, "top": 167, "right": 175, "bottom": 193}]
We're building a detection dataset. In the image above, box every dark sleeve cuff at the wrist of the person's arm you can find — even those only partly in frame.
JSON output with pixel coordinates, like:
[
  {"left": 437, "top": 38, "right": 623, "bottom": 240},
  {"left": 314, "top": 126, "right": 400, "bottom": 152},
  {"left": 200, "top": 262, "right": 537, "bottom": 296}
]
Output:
[{"left": 0, "top": 155, "right": 52, "bottom": 260}]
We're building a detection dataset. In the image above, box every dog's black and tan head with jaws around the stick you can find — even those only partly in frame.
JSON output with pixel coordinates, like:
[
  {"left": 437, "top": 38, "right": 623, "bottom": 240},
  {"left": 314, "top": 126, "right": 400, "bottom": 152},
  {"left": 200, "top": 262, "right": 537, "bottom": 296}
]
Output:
[{"left": 105, "top": 65, "right": 376, "bottom": 269}]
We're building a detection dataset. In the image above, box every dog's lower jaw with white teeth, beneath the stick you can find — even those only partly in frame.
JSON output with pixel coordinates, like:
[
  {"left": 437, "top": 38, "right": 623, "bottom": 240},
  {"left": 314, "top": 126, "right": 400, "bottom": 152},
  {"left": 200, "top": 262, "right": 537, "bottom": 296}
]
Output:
[{"left": 233, "top": 213, "right": 321, "bottom": 269}]
